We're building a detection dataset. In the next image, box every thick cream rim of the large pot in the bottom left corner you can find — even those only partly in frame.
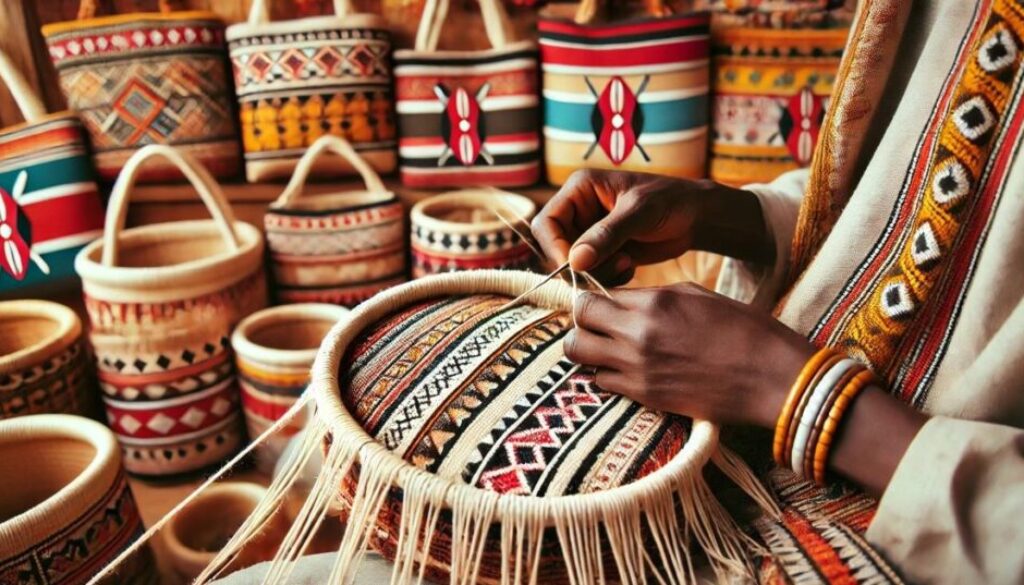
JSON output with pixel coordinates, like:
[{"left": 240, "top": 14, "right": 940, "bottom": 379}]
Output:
[{"left": 0, "top": 414, "right": 121, "bottom": 556}]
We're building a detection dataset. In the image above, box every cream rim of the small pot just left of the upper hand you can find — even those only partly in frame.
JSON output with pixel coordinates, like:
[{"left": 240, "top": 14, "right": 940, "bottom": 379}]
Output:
[{"left": 409, "top": 187, "right": 537, "bottom": 239}]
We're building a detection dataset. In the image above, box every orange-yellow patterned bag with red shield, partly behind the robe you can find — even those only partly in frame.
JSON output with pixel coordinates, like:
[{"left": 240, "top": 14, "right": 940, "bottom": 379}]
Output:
[{"left": 711, "top": 28, "right": 849, "bottom": 185}]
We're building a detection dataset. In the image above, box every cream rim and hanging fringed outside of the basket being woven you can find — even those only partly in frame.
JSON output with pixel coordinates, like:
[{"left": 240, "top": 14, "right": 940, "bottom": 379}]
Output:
[{"left": 184, "top": 270, "right": 770, "bottom": 585}]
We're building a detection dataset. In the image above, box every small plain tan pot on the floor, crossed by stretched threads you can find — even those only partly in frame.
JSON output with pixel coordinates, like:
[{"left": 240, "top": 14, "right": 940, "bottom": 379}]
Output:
[{"left": 164, "top": 482, "right": 288, "bottom": 581}]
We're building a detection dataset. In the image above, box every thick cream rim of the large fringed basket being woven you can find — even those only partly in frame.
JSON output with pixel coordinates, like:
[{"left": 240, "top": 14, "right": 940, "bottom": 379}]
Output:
[{"left": 310, "top": 270, "right": 719, "bottom": 523}]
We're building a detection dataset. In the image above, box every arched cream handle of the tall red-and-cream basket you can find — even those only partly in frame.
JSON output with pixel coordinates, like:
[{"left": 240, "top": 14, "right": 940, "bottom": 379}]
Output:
[{"left": 100, "top": 144, "right": 242, "bottom": 266}]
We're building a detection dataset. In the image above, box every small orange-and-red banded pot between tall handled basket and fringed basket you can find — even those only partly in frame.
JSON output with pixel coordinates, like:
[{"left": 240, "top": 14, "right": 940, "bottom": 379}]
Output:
[{"left": 231, "top": 303, "right": 348, "bottom": 472}]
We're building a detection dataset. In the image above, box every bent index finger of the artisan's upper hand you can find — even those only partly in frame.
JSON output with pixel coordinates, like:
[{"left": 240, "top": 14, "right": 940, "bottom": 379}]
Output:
[{"left": 530, "top": 172, "right": 604, "bottom": 264}]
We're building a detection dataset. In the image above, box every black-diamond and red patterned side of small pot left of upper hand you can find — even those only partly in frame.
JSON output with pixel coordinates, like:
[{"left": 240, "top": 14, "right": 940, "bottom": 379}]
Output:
[{"left": 412, "top": 218, "right": 535, "bottom": 279}]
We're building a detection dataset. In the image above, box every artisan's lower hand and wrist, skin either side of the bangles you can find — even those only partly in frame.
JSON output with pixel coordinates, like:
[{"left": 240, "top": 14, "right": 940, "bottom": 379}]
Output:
[{"left": 565, "top": 285, "right": 927, "bottom": 495}]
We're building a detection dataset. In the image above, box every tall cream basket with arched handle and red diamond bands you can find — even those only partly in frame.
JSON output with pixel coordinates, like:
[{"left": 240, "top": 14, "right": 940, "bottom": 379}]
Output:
[{"left": 75, "top": 144, "right": 266, "bottom": 475}]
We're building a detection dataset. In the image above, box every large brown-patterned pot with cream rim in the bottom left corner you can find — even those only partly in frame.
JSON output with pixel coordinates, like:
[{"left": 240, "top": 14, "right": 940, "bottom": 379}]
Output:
[{"left": 0, "top": 415, "right": 158, "bottom": 585}]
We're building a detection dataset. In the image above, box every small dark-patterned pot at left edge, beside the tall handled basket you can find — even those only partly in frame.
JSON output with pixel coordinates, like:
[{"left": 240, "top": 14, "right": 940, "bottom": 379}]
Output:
[{"left": 0, "top": 300, "right": 99, "bottom": 419}]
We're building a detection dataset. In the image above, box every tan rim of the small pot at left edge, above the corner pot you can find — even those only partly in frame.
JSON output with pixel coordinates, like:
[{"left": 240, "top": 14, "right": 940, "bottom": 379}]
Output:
[{"left": 0, "top": 299, "right": 82, "bottom": 372}]
